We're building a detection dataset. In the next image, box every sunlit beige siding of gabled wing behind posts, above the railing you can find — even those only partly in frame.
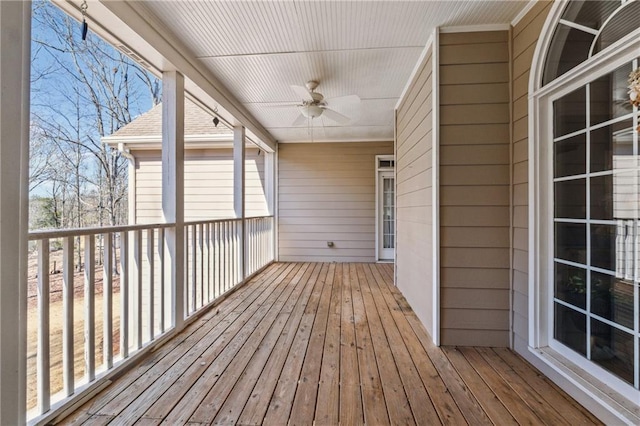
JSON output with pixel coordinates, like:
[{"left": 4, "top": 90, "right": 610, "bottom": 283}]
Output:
[{"left": 132, "top": 149, "right": 268, "bottom": 223}]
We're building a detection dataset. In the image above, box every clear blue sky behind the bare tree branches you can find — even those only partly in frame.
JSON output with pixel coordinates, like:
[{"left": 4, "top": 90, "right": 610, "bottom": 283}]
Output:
[{"left": 30, "top": 0, "right": 160, "bottom": 197}]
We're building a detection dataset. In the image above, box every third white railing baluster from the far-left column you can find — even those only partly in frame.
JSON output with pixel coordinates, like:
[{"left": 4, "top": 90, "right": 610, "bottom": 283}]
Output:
[{"left": 84, "top": 234, "right": 96, "bottom": 382}]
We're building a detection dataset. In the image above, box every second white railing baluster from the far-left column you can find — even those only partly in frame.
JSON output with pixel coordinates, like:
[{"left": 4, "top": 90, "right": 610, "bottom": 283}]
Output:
[{"left": 62, "top": 236, "right": 74, "bottom": 396}]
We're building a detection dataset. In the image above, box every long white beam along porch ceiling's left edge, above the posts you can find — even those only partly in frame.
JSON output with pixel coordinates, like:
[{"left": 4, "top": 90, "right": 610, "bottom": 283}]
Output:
[{"left": 53, "top": 0, "right": 277, "bottom": 152}]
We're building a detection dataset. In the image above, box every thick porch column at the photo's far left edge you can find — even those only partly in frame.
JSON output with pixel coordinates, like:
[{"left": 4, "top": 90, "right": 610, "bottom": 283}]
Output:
[{"left": 0, "top": 1, "right": 31, "bottom": 425}]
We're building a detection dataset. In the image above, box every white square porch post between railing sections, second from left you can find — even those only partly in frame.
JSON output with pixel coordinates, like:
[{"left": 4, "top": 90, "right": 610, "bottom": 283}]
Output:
[{"left": 162, "top": 71, "right": 185, "bottom": 330}]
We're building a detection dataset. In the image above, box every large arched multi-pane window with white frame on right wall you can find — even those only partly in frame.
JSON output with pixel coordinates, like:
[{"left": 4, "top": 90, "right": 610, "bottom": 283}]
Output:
[{"left": 530, "top": 0, "right": 640, "bottom": 401}]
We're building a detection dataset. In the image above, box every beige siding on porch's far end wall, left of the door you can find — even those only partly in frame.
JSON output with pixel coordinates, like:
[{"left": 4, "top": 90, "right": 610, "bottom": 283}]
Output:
[{"left": 278, "top": 142, "right": 393, "bottom": 262}]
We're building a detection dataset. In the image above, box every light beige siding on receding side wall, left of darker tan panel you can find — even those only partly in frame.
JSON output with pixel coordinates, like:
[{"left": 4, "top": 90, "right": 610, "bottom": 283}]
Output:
[{"left": 395, "top": 44, "right": 434, "bottom": 335}]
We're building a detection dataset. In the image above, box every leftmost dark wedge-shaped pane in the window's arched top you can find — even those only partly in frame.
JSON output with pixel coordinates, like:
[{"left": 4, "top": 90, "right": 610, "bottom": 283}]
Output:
[{"left": 542, "top": 24, "right": 594, "bottom": 84}]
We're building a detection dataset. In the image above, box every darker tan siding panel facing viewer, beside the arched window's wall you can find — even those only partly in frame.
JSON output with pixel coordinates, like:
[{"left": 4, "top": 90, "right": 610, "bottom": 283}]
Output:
[{"left": 440, "top": 31, "right": 511, "bottom": 346}]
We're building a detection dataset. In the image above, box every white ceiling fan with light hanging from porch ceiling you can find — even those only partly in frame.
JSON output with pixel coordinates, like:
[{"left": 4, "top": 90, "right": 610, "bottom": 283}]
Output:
[{"left": 282, "top": 80, "right": 360, "bottom": 126}]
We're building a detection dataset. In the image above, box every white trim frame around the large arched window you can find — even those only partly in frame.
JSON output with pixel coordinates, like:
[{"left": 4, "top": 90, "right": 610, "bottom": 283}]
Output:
[{"left": 528, "top": 1, "right": 640, "bottom": 423}]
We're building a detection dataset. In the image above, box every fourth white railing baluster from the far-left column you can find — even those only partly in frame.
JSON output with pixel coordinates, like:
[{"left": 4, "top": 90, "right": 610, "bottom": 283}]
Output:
[{"left": 102, "top": 232, "right": 113, "bottom": 370}]
